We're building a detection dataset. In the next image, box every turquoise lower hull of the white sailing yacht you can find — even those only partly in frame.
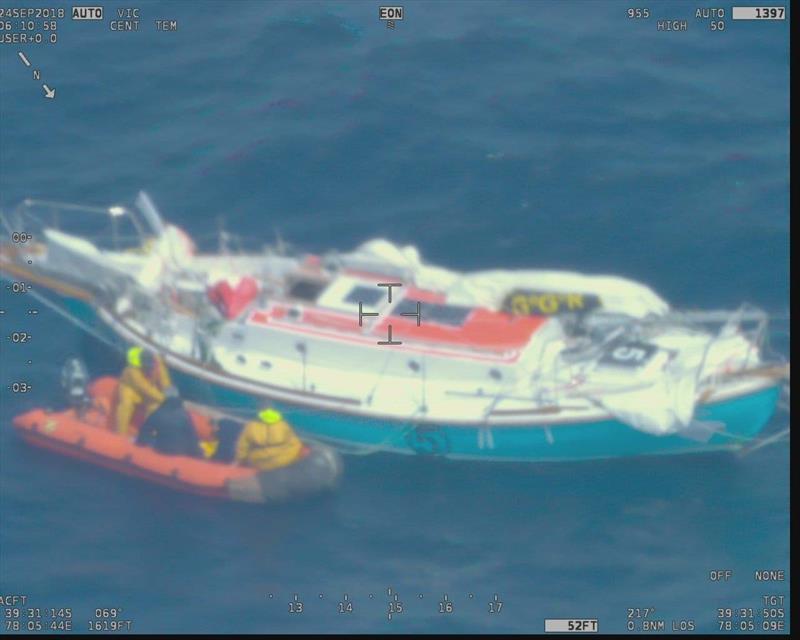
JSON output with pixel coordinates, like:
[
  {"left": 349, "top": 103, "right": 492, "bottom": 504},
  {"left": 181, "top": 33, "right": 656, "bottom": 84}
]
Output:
[{"left": 62, "top": 300, "right": 780, "bottom": 462}]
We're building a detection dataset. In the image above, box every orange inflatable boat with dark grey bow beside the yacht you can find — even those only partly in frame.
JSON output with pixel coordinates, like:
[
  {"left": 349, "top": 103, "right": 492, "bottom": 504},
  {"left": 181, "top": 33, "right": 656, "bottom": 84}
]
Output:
[{"left": 13, "top": 378, "right": 342, "bottom": 503}]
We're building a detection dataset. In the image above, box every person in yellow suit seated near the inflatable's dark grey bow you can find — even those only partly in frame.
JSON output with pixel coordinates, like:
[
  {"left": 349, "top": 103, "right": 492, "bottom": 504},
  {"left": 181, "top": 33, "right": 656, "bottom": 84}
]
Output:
[{"left": 236, "top": 409, "right": 303, "bottom": 471}]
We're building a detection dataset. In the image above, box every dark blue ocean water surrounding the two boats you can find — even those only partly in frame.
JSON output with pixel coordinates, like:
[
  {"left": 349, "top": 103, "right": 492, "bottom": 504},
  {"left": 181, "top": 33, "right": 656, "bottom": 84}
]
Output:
[{"left": 0, "top": 0, "right": 789, "bottom": 633}]
